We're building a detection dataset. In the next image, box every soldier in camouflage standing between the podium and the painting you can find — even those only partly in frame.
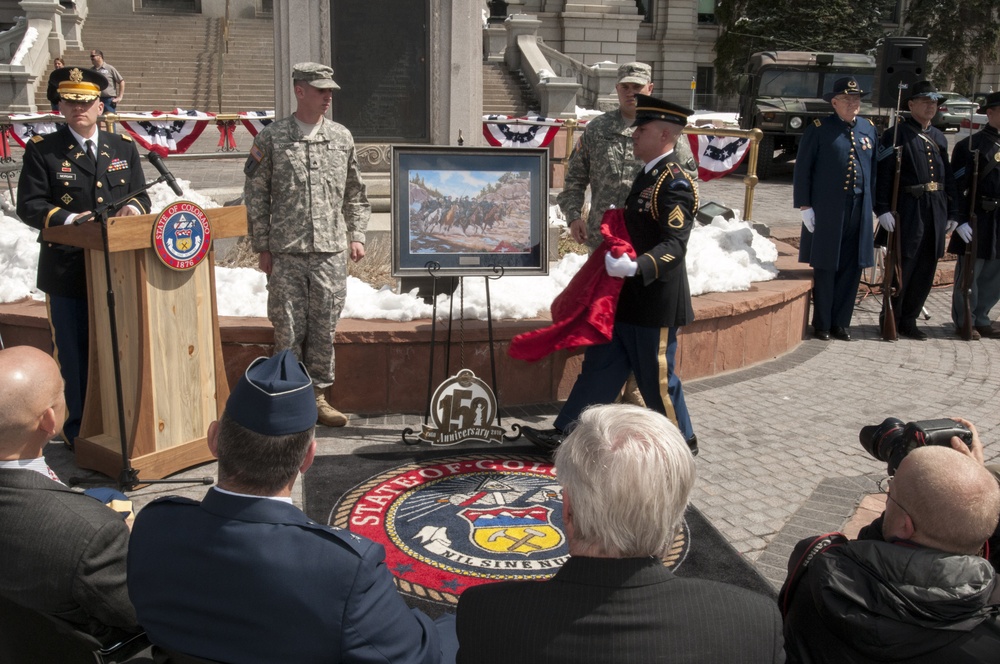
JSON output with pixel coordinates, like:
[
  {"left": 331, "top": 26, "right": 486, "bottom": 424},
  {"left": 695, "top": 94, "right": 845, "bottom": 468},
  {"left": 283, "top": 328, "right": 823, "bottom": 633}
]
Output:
[{"left": 243, "top": 62, "right": 371, "bottom": 426}]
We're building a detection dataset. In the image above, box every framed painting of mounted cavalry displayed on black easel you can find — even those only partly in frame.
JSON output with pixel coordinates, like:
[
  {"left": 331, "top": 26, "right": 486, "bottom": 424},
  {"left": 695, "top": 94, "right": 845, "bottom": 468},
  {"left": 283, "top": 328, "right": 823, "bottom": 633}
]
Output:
[{"left": 393, "top": 148, "right": 548, "bottom": 270}]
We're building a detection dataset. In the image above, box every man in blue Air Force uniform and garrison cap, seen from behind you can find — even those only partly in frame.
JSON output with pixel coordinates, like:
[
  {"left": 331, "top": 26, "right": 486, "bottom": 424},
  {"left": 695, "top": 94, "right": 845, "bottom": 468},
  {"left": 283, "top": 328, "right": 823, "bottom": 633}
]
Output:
[{"left": 128, "top": 350, "right": 458, "bottom": 664}]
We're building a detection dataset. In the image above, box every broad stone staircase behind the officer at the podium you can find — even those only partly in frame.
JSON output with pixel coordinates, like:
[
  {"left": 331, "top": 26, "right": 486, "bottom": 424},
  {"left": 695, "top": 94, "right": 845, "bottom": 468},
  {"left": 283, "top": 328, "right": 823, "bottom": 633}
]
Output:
[{"left": 36, "top": 10, "right": 274, "bottom": 113}]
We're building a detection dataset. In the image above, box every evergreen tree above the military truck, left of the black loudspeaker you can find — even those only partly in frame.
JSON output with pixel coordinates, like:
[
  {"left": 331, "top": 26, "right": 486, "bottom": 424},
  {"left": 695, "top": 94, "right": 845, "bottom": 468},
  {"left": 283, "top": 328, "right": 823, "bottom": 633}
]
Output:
[{"left": 715, "top": 0, "right": 892, "bottom": 94}]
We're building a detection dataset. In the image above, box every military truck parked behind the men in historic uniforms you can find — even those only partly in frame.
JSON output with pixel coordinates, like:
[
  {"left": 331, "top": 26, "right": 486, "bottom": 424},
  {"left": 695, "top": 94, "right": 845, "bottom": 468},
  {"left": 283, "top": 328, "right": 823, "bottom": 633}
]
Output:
[{"left": 739, "top": 51, "right": 881, "bottom": 180}]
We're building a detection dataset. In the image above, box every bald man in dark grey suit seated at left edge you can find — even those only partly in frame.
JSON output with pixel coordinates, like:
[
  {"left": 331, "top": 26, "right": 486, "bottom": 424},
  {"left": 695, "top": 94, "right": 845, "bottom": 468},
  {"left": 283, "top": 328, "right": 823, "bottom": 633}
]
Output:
[{"left": 0, "top": 346, "right": 141, "bottom": 644}]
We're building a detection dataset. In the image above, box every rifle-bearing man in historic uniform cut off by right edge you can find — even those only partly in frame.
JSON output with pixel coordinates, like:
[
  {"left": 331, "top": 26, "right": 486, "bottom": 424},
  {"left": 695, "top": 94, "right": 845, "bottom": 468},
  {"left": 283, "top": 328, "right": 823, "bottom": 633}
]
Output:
[{"left": 948, "top": 92, "right": 1000, "bottom": 339}]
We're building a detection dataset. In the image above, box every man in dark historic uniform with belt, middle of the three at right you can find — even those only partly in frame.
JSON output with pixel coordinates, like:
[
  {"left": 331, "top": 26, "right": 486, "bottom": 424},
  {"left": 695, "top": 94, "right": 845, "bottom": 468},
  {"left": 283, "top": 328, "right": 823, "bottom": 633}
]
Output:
[{"left": 875, "top": 81, "right": 957, "bottom": 341}]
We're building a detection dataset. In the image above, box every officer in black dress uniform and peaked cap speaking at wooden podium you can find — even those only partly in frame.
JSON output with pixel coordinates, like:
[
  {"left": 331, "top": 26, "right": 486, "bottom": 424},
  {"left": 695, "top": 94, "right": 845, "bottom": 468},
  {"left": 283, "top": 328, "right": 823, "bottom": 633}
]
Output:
[{"left": 17, "top": 67, "right": 149, "bottom": 447}]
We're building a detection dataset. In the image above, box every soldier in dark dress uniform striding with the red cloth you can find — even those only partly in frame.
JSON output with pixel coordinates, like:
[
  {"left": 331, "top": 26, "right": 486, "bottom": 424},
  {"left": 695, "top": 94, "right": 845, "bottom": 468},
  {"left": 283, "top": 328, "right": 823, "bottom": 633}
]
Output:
[{"left": 521, "top": 95, "right": 698, "bottom": 454}]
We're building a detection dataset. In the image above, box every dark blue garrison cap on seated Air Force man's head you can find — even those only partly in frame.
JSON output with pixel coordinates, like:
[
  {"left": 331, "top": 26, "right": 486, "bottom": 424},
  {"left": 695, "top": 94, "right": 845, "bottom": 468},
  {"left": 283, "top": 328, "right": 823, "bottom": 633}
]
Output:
[{"left": 226, "top": 350, "right": 317, "bottom": 436}]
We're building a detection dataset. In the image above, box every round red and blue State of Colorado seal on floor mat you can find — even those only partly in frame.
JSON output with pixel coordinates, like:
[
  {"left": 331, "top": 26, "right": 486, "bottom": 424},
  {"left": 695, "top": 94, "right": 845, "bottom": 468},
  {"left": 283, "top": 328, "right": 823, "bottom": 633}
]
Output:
[{"left": 330, "top": 453, "right": 688, "bottom": 604}]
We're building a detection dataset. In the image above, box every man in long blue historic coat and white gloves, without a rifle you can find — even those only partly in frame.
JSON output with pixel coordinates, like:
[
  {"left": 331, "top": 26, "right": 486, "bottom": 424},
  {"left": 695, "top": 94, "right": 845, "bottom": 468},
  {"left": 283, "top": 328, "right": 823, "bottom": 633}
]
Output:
[{"left": 793, "top": 76, "right": 878, "bottom": 341}]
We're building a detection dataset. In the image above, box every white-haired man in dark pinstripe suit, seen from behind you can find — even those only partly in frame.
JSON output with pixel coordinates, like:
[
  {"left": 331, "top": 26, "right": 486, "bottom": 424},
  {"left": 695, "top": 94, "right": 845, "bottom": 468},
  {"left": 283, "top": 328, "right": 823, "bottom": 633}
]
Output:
[{"left": 457, "top": 404, "right": 784, "bottom": 664}]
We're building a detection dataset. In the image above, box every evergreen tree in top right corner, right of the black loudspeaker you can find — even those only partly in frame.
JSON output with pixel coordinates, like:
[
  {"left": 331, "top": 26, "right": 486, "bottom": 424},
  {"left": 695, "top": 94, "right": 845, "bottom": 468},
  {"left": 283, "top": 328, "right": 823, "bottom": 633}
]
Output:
[{"left": 906, "top": 0, "right": 1000, "bottom": 94}]
